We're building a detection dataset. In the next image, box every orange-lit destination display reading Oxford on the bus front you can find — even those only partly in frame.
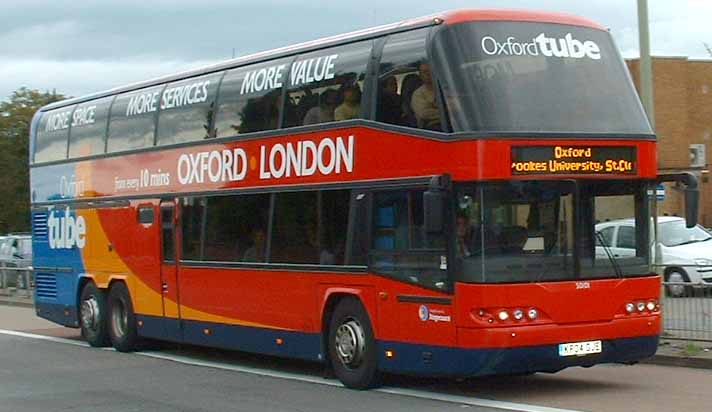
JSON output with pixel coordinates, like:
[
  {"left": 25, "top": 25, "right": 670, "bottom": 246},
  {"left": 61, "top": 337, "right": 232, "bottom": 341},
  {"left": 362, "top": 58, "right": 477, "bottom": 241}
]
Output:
[{"left": 511, "top": 145, "right": 637, "bottom": 175}]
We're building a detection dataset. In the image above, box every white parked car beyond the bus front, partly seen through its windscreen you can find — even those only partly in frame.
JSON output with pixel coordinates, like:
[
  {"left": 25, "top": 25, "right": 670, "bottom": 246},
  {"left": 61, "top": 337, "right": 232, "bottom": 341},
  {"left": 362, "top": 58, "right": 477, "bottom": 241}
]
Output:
[{"left": 596, "top": 216, "right": 712, "bottom": 296}]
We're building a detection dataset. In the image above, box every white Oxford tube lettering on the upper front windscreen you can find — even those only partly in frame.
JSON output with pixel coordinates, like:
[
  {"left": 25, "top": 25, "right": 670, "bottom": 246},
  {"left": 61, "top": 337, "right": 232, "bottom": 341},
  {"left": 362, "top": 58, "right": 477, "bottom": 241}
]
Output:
[{"left": 482, "top": 33, "right": 601, "bottom": 60}]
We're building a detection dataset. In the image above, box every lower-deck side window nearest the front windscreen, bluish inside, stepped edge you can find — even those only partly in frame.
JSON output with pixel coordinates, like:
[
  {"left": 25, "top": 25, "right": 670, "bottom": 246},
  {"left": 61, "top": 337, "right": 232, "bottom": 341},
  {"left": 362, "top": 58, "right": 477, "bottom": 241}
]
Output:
[{"left": 370, "top": 190, "right": 447, "bottom": 289}]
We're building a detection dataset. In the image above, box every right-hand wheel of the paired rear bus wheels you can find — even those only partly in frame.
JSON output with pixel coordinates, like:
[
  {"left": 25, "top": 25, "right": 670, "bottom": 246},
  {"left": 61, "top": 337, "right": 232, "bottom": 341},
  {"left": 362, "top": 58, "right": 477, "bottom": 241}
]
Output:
[{"left": 108, "top": 282, "right": 138, "bottom": 352}]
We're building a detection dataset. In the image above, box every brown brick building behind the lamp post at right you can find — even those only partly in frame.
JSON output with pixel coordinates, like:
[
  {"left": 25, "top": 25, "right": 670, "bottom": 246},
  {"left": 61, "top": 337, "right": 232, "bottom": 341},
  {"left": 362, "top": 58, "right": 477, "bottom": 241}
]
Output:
[{"left": 627, "top": 57, "right": 712, "bottom": 227}]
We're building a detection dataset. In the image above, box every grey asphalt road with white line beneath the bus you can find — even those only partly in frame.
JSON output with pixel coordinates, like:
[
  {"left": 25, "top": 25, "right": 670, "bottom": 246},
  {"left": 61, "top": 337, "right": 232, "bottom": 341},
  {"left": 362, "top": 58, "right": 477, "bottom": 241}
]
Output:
[{"left": 0, "top": 306, "right": 712, "bottom": 412}]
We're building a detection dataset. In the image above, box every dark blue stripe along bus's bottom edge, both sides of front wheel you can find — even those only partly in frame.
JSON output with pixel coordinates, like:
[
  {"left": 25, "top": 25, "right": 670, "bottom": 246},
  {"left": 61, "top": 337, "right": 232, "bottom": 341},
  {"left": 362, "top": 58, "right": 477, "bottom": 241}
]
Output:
[{"left": 138, "top": 316, "right": 658, "bottom": 376}]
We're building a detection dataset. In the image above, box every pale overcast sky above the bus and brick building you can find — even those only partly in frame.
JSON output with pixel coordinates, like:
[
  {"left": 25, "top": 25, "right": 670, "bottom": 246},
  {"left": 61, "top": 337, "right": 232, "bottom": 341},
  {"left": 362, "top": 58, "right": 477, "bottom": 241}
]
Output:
[{"left": 0, "top": 0, "right": 712, "bottom": 100}]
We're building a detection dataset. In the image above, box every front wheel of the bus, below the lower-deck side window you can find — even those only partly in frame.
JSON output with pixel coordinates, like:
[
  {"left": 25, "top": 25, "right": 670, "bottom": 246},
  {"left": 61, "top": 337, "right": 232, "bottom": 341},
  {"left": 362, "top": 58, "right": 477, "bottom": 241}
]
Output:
[{"left": 328, "top": 298, "right": 380, "bottom": 389}]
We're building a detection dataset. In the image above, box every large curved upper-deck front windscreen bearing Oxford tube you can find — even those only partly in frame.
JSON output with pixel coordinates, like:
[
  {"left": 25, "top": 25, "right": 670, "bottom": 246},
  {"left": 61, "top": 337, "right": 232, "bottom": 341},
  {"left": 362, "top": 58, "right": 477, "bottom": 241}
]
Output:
[{"left": 433, "top": 22, "right": 652, "bottom": 134}]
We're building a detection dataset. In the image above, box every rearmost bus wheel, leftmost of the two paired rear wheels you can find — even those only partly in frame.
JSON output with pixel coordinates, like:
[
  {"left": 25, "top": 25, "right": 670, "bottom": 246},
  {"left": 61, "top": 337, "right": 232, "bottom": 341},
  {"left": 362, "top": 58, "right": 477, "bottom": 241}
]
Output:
[{"left": 79, "top": 281, "right": 110, "bottom": 348}]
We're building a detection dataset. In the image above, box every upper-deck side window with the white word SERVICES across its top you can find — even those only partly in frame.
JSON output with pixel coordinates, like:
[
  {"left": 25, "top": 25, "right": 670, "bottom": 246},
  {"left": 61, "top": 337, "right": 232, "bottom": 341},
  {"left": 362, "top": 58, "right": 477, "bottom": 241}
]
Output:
[{"left": 157, "top": 74, "right": 222, "bottom": 145}]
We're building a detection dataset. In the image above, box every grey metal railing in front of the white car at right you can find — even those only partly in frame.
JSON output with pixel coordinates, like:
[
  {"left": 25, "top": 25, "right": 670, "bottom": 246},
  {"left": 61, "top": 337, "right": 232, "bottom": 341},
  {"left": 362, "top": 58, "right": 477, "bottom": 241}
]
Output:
[{"left": 661, "top": 282, "right": 712, "bottom": 342}]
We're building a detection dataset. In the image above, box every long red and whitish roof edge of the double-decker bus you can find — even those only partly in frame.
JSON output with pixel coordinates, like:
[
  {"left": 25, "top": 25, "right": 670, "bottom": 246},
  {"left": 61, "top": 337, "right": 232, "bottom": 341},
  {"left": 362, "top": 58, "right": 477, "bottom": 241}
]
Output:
[{"left": 40, "top": 9, "right": 605, "bottom": 111}]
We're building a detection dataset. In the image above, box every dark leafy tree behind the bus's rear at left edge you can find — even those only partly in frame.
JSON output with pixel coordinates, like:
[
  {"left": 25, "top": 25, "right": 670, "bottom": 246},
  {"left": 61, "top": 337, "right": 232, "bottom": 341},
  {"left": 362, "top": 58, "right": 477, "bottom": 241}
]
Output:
[{"left": 0, "top": 87, "right": 64, "bottom": 233}]
